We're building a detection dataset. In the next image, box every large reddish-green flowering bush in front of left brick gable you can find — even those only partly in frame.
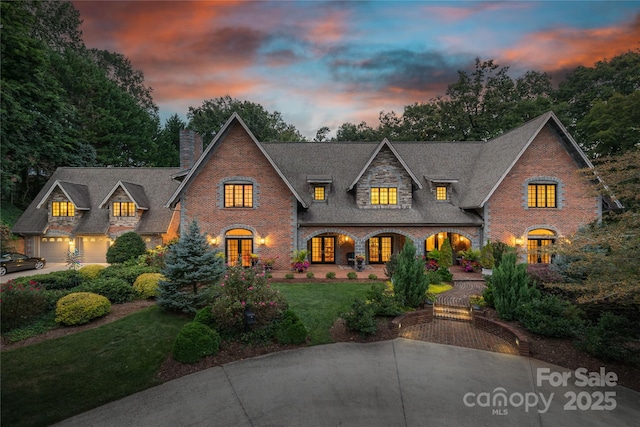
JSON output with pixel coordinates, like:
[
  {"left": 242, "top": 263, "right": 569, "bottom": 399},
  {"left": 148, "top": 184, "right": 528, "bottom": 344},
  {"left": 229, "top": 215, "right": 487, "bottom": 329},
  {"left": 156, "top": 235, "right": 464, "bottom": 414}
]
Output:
[{"left": 212, "top": 266, "right": 287, "bottom": 335}]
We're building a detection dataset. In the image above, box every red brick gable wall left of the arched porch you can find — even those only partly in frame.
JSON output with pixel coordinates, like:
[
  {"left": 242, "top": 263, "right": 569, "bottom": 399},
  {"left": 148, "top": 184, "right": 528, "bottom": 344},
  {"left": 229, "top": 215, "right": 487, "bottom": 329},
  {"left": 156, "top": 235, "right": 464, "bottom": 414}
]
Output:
[{"left": 179, "top": 124, "right": 297, "bottom": 268}]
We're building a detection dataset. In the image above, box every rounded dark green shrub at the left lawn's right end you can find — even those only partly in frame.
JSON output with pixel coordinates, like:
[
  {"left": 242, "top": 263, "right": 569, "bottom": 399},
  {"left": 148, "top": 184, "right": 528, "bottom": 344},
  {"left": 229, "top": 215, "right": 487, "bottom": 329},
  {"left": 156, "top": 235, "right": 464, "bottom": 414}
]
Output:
[{"left": 173, "top": 322, "right": 221, "bottom": 363}]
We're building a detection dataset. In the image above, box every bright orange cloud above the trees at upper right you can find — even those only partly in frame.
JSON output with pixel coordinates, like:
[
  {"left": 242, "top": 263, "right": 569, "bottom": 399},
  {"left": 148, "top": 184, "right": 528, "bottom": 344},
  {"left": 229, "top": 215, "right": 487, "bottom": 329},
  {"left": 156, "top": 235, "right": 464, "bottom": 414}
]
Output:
[{"left": 503, "top": 14, "right": 640, "bottom": 71}]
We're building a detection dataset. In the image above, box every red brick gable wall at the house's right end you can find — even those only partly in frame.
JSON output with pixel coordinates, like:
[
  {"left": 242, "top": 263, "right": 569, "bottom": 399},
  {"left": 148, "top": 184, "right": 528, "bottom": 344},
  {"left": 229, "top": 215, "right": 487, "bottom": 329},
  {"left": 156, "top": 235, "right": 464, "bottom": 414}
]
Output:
[{"left": 484, "top": 125, "right": 599, "bottom": 245}]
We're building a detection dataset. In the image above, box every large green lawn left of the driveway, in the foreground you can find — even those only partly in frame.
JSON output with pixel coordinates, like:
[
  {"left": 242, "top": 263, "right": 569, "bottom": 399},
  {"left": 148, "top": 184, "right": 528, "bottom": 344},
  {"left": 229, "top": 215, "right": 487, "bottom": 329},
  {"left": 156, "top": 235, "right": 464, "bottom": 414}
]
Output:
[{"left": 0, "top": 306, "right": 189, "bottom": 426}]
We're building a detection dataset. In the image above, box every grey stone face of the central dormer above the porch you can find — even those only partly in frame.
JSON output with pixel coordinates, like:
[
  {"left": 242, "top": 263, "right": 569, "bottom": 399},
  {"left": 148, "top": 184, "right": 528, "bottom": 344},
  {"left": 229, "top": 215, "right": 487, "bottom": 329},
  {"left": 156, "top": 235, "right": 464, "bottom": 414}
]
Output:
[{"left": 356, "top": 147, "right": 412, "bottom": 209}]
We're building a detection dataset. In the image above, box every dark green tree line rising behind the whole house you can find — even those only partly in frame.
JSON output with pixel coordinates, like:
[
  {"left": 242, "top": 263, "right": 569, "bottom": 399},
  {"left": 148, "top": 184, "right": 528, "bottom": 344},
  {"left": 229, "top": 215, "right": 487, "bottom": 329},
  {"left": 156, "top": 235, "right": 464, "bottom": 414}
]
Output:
[{"left": 0, "top": 0, "right": 640, "bottom": 207}]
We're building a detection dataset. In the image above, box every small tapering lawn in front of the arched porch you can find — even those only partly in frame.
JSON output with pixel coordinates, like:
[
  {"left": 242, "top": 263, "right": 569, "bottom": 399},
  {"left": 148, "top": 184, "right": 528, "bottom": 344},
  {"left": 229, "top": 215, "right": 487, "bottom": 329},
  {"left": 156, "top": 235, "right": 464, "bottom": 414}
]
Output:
[{"left": 272, "top": 282, "right": 374, "bottom": 345}]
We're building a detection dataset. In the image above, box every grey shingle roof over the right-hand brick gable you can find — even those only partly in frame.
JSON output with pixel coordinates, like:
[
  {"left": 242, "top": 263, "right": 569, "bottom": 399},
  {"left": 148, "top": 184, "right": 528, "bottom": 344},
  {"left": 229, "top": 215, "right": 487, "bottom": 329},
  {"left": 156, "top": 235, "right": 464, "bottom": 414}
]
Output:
[{"left": 460, "top": 112, "right": 593, "bottom": 208}]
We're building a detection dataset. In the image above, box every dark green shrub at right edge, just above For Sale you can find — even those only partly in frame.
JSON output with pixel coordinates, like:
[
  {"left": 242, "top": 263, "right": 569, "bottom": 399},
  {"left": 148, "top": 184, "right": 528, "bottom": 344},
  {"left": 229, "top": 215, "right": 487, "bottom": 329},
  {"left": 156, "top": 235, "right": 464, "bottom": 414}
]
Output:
[{"left": 575, "top": 311, "right": 639, "bottom": 364}]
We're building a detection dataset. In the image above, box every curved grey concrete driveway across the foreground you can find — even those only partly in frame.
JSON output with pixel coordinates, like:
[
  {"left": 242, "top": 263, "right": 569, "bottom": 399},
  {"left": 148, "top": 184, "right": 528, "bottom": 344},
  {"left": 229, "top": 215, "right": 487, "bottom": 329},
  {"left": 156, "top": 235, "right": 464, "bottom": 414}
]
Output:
[{"left": 56, "top": 338, "right": 640, "bottom": 427}]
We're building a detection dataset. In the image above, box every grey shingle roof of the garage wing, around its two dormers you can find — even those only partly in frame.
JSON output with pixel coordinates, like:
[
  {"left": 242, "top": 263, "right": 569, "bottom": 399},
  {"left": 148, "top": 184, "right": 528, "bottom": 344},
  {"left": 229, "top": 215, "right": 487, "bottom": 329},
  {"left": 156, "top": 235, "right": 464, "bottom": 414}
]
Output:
[{"left": 13, "top": 168, "right": 180, "bottom": 234}]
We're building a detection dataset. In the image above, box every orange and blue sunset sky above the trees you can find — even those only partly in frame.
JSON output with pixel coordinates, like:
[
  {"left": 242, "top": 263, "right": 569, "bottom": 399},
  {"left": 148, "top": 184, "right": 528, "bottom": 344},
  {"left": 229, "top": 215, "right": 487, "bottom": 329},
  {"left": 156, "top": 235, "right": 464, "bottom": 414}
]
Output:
[{"left": 73, "top": 1, "right": 640, "bottom": 138}]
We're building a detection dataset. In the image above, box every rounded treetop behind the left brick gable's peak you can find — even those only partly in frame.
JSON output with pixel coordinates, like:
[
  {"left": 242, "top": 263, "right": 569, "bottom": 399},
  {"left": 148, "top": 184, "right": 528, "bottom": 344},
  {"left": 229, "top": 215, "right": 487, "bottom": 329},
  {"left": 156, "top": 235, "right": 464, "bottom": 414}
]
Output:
[{"left": 187, "top": 95, "right": 305, "bottom": 144}]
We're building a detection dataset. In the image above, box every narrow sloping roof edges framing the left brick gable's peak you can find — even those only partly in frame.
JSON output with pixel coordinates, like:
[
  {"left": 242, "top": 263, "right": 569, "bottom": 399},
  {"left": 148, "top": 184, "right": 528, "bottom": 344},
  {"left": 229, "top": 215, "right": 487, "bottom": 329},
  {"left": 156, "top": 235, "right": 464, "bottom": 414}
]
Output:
[{"left": 165, "top": 113, "right": 308, "bottom": 208}]
